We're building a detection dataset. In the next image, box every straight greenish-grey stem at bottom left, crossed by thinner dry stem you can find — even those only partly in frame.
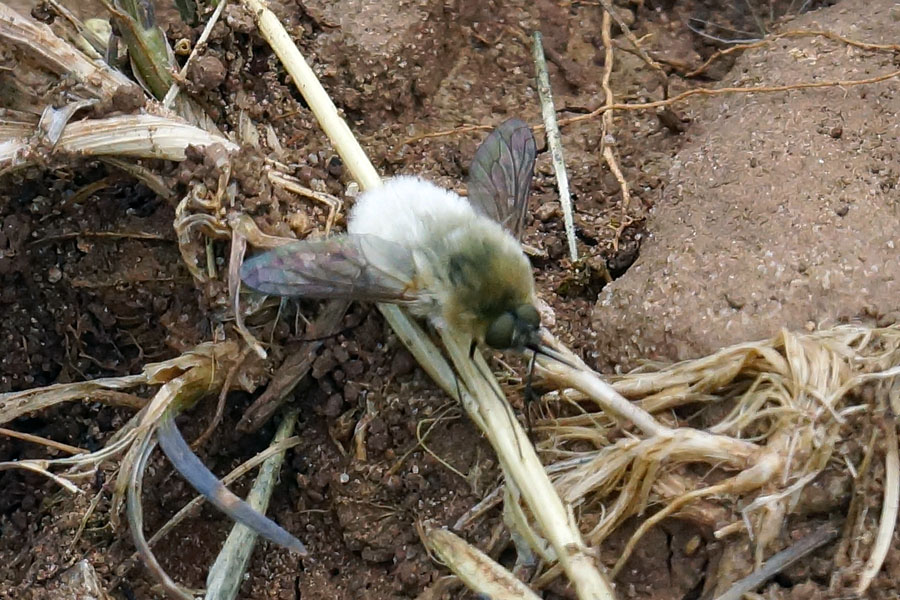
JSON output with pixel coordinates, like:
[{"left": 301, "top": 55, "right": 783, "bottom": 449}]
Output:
[{"left": 205, "top": 410, "right": 298, "bottom": 600}]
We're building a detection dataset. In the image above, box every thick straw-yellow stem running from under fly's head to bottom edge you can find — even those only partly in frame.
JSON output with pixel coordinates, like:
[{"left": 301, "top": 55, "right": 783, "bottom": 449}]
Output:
[{"left": 441, "top": 331, "right": 615, "bottom": 600}]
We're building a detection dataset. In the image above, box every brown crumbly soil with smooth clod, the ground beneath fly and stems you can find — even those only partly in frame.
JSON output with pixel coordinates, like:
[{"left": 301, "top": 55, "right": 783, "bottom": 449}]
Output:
[{"left": 0, "top": 0, "right": 900, "bottom": 600}]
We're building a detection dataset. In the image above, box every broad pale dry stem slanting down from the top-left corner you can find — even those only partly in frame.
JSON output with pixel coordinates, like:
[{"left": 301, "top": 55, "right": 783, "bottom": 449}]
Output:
[{"left": 0, "top": 3, "right": 132, "bottom": 98}]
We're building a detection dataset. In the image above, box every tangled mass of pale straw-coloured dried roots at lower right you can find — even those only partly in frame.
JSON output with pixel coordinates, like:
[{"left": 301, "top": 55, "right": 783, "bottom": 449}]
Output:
[{"left": 538, "top": 326, "right": 900, "bottom": 588}]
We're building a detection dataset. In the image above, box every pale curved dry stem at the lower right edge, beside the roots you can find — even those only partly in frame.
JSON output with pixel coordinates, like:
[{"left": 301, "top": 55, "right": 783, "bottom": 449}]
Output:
[{"left": 856, "top": 416, "right": 900, "bottom": 596}]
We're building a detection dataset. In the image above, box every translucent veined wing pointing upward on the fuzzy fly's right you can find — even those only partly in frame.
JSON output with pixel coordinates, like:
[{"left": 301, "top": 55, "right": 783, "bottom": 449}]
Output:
[{"left": 469, "top": 119, "right": 536, "bottom": 239}]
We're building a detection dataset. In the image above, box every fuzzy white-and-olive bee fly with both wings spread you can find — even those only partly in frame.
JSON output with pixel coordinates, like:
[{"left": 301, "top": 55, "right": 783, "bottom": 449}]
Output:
[{"left": 241, "top": 119, "right": 556, "bottom": 358}]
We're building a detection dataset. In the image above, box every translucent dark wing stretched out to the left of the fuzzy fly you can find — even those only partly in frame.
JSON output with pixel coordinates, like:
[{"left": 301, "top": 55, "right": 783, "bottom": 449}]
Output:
[{"left": 241, "top": 234, "right": 416, "bottom": 303}]
